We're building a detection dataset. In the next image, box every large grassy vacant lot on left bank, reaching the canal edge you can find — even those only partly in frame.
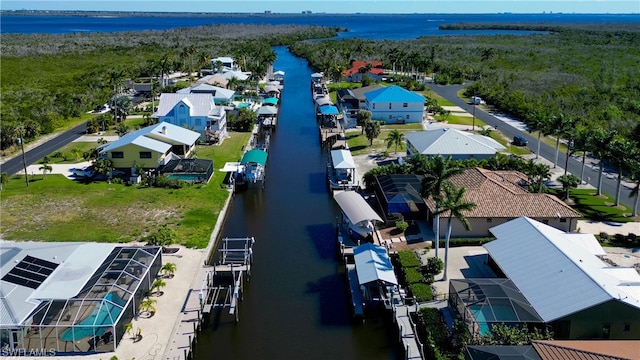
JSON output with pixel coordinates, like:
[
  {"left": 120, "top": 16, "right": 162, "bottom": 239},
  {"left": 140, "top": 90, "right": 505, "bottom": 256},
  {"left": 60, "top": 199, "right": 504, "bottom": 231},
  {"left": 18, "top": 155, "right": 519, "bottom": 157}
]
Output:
[{"left": 0, "top": 133, "right": 250, "bottom": 248}]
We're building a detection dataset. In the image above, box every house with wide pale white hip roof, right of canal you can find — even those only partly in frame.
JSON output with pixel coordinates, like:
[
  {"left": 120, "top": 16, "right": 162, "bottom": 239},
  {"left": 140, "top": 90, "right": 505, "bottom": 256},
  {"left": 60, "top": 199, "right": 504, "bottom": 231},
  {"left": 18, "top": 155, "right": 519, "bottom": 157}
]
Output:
[{"left": 405, "top": 128, "right": 505, "bottom": 160}]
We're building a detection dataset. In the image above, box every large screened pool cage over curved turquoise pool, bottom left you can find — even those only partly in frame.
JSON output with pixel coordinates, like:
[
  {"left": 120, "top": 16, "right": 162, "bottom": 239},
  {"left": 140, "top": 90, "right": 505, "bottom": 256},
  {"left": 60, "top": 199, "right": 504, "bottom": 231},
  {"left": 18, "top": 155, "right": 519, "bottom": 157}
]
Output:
[{"left": 12, "top": 246, "right": 162, "bottom": 354}]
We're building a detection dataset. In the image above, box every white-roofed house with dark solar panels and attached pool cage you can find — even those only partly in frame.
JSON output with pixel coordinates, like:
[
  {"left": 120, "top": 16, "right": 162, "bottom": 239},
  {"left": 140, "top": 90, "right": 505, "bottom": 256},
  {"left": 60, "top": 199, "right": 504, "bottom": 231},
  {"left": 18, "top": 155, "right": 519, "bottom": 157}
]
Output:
[{"left": 0, "top": 242, "right": 162, "bottom": 355}]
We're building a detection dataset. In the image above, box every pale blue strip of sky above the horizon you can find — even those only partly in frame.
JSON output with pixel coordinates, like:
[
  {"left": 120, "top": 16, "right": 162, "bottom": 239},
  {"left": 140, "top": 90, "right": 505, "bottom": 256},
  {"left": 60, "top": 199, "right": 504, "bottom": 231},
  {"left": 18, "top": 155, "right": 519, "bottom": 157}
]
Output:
[{"left": 0, "top": 0, "right": 640, "bottom": 14}]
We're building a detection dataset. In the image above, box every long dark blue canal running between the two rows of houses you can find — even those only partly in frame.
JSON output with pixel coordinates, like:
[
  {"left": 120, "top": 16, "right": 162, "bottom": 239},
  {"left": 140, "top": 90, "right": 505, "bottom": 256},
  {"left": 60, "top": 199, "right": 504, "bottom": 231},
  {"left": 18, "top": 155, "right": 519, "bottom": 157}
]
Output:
[{"left": 195, "top": 47, "right": 400, "bottom": 360}]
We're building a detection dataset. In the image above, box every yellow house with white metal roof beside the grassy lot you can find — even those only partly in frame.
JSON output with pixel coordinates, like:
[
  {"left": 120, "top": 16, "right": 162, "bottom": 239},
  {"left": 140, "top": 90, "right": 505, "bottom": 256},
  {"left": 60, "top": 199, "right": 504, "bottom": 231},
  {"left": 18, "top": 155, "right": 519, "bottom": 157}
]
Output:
[{"left": 98, "top": 122, "right": 200, "bottom": 170}]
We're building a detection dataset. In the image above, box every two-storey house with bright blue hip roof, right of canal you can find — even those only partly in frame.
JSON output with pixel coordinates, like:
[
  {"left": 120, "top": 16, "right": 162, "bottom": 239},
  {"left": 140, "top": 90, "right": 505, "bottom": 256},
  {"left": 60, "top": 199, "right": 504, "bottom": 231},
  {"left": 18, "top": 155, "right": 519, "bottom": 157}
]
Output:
[{"left": 364, "top": 85, "right": 426, "bottom": 124}]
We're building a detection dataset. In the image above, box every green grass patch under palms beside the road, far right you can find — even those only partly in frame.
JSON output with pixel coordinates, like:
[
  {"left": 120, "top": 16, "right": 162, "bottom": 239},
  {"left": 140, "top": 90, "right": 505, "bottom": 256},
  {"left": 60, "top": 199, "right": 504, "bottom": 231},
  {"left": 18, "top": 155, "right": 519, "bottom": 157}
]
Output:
[{"left": 551, "top": 189, "right": 634, "bottom": 222}]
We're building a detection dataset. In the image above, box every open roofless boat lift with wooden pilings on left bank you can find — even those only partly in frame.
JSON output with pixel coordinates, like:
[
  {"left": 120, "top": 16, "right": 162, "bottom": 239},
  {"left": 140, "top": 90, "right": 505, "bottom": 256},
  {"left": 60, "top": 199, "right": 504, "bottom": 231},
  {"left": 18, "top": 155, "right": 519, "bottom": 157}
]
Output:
[{"left": 203, "top": 237, "right": 255, "bottom": 322}]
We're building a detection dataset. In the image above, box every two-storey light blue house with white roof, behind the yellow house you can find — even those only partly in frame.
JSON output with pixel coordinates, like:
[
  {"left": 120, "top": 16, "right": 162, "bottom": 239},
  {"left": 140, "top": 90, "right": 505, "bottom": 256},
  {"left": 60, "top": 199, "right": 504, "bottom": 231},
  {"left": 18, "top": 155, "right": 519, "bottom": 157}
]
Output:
[{"left": 151, "top": 89, "right": 228, "bottom": 141}]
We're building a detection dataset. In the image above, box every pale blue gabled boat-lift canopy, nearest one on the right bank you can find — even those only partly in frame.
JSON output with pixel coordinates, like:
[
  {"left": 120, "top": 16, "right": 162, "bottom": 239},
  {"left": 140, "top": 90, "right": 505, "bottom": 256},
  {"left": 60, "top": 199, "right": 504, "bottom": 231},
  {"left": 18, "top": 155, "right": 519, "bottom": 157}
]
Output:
[{"left": 353, "top": 243, "right": 398, "bottom": 286}]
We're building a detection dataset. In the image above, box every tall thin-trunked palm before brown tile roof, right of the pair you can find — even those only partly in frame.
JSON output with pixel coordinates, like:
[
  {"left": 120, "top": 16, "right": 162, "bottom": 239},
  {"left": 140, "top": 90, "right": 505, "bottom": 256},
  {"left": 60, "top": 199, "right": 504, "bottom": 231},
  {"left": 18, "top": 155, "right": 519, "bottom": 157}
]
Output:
[{"left": 438, "top": 182, "right": 478, "bottom": 281}]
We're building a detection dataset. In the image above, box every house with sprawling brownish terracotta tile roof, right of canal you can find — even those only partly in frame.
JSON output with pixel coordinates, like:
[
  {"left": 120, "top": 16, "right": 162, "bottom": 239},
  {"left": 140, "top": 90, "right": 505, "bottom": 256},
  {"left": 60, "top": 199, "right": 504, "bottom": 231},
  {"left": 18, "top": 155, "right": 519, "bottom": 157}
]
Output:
[{"left": 425, "top": 168, "right": 582, "bottom": 237}]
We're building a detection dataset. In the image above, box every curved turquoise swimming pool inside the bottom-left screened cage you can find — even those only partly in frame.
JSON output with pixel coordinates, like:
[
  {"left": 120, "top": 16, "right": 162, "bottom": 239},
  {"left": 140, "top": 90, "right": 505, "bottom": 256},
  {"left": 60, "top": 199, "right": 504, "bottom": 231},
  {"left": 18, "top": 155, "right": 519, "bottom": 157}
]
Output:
[{"left": 60, "top": 293, "right": 126, "bottom": 341}]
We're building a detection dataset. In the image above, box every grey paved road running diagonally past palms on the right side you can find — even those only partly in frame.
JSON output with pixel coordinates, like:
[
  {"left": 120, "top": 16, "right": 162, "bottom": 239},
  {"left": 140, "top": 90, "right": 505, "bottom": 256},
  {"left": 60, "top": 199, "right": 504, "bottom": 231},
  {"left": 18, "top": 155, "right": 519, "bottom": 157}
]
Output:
[{"left": 427, "top": 83, "right": 633, "bottom": 207}]
